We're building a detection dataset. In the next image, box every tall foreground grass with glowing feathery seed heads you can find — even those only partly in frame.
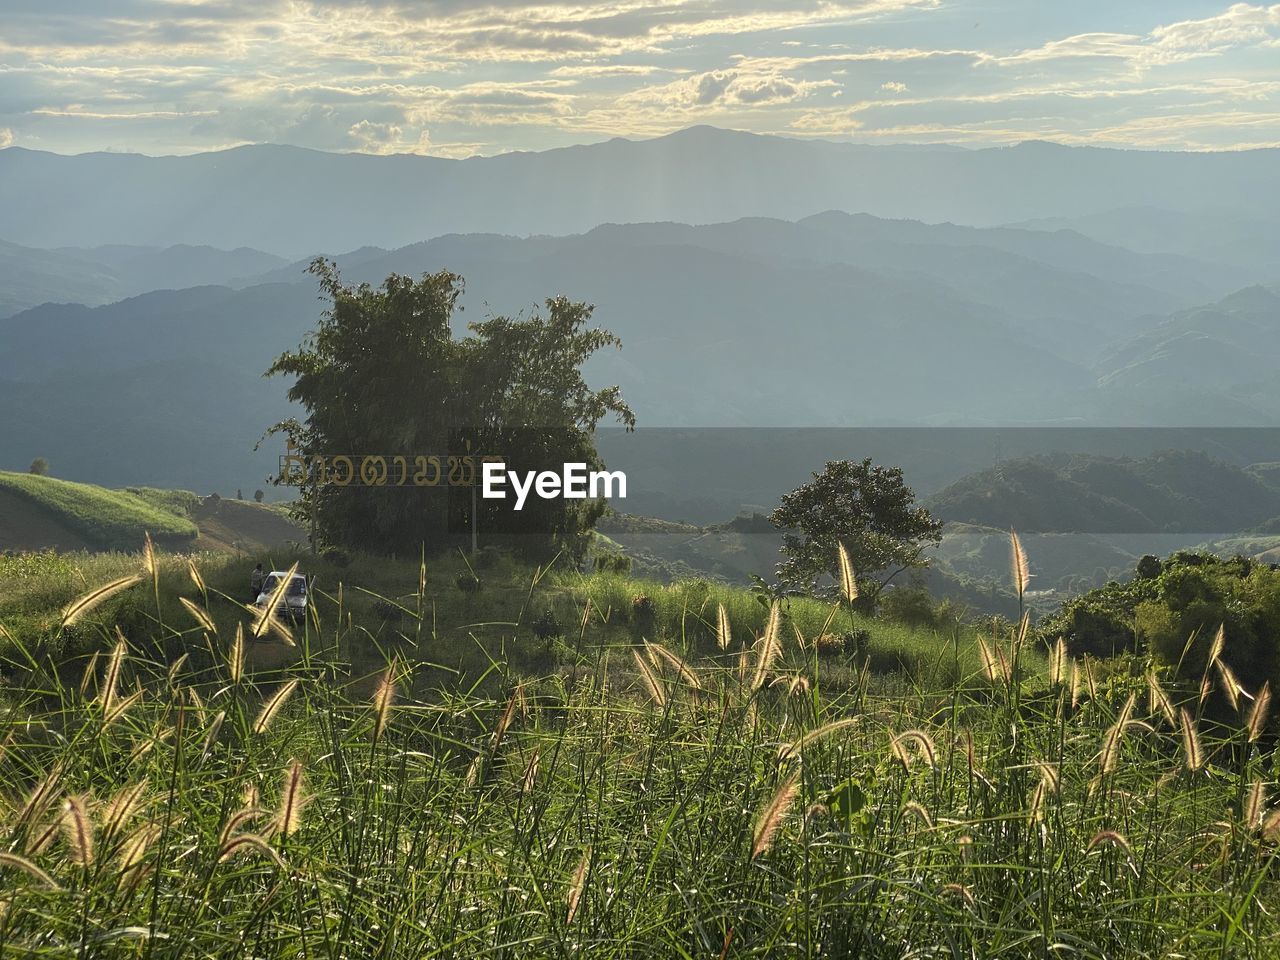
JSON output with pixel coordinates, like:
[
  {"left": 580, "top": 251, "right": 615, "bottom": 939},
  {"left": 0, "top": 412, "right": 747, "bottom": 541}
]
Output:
[{"left": 0, "top": 545, "right": 1280, "bottom": 957}]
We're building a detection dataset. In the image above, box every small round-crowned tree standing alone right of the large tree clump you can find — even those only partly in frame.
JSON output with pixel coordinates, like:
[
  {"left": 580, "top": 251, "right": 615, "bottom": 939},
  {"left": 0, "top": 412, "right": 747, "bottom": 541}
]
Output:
[{"left": 769, "top": 457, "right": 942, "bottom": 604}]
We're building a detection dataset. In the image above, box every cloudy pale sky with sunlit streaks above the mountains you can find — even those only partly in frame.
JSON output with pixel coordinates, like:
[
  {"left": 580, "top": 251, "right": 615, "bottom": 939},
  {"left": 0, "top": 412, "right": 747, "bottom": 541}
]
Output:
[{"left": 0, "top": 0, "right": 1280, "bottom": 157}]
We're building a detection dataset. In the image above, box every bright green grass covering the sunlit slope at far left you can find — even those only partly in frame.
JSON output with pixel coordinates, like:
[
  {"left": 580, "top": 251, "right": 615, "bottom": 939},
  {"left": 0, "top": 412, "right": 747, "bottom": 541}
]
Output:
[{"left": 0, "top": 471, "right": 198, "bottom": 550}]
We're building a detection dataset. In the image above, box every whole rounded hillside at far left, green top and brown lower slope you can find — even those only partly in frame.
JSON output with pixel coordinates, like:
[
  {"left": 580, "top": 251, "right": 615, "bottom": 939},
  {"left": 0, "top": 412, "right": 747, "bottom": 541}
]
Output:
[{"left": 0, "top": 472, "right": 200, "bottom": 550}]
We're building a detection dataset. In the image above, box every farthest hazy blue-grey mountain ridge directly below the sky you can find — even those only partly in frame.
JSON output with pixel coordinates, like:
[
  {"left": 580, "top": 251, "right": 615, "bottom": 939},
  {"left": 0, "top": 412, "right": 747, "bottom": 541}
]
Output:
[{"left": 0, "top": 127, "right": 1280, "bottom": 256}]
